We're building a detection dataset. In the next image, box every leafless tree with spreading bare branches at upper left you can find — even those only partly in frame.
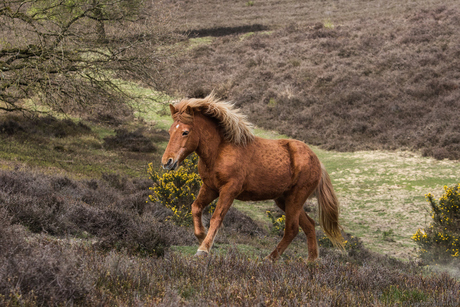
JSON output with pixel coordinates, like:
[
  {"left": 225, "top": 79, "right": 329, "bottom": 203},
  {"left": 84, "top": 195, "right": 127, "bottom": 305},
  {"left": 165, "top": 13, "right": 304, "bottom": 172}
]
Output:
[{"left": 0, "top": 0, "right": 178, "bottom": 112}]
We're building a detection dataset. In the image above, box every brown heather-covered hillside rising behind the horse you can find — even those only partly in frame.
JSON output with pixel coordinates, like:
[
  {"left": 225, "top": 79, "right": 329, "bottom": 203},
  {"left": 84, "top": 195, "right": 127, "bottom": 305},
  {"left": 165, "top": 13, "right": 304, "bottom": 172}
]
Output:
[{"left": 160, "top": 1, "right": 460, "bottom": 159}]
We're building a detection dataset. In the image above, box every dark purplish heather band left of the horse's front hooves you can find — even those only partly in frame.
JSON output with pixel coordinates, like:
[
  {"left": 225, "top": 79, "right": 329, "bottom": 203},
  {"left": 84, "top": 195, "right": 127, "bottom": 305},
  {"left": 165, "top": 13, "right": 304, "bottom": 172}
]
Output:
[{"left": 0, "top": 171, "right": 195, "bottom": 256}]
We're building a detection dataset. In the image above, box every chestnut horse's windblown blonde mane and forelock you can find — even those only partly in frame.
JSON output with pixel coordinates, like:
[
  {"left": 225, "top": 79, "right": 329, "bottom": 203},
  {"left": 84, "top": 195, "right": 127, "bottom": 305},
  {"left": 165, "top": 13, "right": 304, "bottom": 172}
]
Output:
[{"left": 173, "top": 93, "right": 254, "bottom": 146}]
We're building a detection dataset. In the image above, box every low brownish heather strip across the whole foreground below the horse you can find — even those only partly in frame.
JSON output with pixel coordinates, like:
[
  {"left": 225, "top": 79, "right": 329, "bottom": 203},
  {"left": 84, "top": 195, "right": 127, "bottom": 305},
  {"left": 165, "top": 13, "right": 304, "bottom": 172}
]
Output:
[{"left": 0, "top": 189, "right": 460, "bottom": 306}]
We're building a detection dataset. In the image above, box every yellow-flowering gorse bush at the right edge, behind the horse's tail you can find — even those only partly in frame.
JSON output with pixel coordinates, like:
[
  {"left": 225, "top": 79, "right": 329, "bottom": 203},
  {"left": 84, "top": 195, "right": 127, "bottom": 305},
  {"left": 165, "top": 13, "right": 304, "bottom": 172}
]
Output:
[{"left": 412, "top": 184, "right": 460, "bottom": 261}]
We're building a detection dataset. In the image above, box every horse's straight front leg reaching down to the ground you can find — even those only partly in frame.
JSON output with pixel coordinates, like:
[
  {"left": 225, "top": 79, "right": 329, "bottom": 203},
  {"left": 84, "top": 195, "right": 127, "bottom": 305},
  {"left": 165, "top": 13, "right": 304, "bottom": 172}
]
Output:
[{"left": 196, "top": 182, "right": 241, "bottom": 256}]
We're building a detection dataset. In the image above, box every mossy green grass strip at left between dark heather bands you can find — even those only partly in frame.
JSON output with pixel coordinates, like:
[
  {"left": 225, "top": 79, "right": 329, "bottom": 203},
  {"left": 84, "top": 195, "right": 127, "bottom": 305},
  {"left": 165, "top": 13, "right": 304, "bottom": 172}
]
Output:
[{"left": 0, "top": 137, "right": 158, "bottom": 178}]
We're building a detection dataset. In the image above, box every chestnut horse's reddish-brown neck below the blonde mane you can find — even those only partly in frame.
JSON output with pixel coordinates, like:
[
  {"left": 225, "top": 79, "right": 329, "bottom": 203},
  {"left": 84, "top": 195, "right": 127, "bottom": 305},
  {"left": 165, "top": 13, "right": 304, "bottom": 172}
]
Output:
[{"left": 195, "top": 116, "right": 224, "bottom": 168}]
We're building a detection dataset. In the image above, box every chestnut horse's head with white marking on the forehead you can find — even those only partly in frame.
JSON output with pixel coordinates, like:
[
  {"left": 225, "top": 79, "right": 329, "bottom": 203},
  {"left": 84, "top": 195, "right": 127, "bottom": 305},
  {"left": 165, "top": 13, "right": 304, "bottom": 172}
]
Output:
[{"left": 161, "top": 105, "right": 199, "bottom": 170}]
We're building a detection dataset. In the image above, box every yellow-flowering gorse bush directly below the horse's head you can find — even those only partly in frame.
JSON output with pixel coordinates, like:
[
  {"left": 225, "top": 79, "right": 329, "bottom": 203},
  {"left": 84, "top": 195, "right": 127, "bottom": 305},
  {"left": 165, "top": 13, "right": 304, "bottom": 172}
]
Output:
[{"left": 148, "top": 154, "right": 202, "bottom": 226}]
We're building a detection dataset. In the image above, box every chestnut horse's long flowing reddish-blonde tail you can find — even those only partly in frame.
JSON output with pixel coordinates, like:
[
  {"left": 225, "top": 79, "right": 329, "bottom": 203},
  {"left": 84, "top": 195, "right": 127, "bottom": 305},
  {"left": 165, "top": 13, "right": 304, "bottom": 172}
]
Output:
[{"left": 316, "top": 163, "right": 345, "bottom": 250}]
